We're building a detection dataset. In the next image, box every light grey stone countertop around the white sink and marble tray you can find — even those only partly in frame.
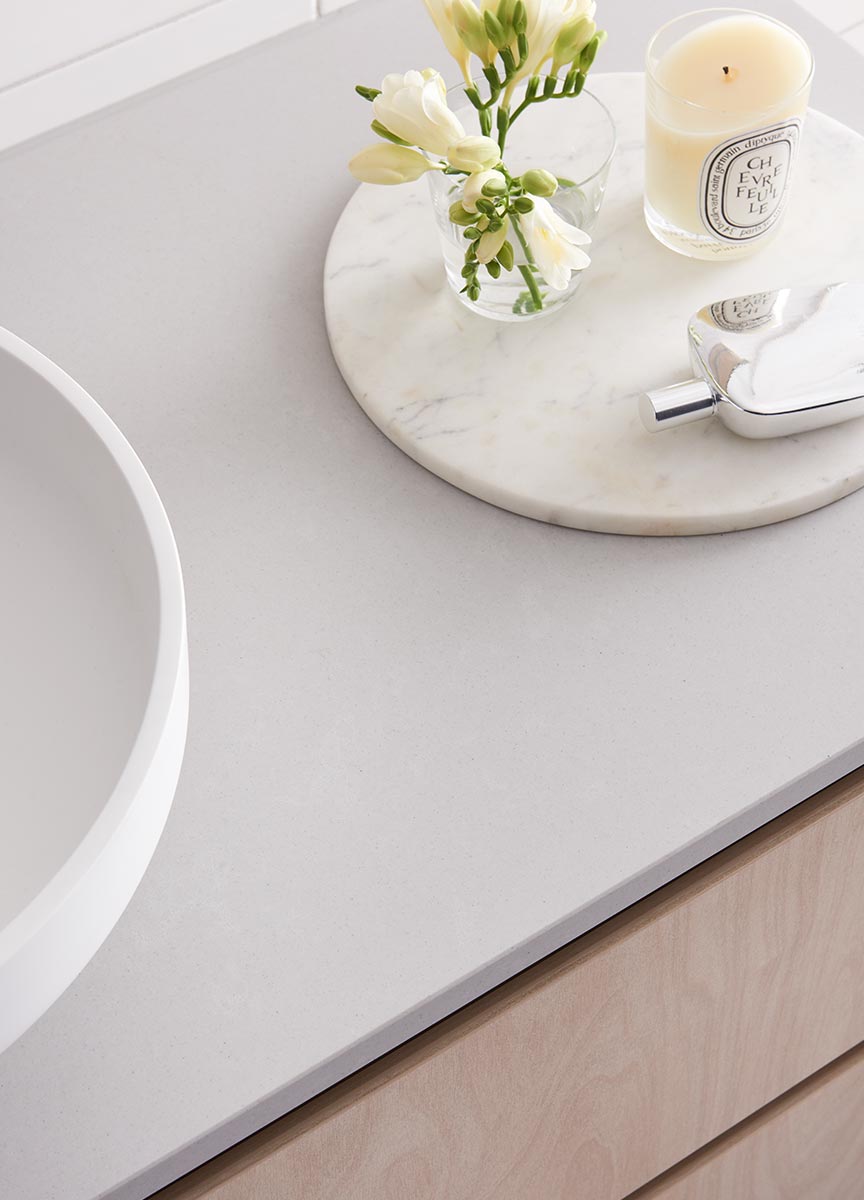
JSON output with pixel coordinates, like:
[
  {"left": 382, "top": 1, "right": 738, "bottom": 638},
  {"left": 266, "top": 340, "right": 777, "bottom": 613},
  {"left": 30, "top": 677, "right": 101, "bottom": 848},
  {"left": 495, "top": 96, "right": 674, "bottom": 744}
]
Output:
[{"left": 0, "top": 0, "right": 864, "bottom": 1200}]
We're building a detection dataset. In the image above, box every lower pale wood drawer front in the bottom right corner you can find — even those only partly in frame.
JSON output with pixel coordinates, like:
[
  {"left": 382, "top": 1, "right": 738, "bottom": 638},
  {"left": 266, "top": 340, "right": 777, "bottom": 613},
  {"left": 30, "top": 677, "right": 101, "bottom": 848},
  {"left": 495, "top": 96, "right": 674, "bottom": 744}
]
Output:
[{"left": 629, "top": 1046, "right": 864, "bottom": 1200}]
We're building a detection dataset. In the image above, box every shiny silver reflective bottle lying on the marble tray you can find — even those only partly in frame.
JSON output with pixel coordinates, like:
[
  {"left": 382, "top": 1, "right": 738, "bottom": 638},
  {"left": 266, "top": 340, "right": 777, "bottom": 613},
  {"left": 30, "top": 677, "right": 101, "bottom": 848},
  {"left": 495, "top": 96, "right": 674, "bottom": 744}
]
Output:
[{"left": 640, "top": 283, "right": 864, "bottom": 438}]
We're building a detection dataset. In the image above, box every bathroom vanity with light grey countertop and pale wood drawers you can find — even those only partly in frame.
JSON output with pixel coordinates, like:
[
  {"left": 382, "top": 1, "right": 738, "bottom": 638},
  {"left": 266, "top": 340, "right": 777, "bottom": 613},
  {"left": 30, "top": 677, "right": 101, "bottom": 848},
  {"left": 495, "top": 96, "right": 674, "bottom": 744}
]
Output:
[{"left": 0, "top": 0, "right": 864, "bottom": 1200}]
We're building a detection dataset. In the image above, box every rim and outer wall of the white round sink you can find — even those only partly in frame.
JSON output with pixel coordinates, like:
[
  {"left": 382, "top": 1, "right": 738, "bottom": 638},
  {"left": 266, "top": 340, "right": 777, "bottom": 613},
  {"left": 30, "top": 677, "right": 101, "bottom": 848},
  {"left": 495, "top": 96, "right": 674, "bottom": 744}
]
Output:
[{"left": 0, "top": 326, "right": 188, "bottom": 1052}]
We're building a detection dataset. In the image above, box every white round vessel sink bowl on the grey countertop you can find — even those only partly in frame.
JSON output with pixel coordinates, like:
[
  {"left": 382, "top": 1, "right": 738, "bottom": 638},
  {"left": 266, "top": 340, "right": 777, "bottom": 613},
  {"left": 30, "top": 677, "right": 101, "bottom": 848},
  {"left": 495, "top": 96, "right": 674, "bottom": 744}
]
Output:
[{"left": 0, "top": 329, "right": 188, "bottom": 1052}]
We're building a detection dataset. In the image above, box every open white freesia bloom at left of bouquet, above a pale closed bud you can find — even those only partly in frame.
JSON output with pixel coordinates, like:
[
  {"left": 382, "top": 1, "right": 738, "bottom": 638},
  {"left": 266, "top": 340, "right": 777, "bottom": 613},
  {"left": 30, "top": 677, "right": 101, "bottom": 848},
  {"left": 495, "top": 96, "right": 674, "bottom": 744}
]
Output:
[{"left": 372, "top": 67, "right": 466, "bottom": 155}]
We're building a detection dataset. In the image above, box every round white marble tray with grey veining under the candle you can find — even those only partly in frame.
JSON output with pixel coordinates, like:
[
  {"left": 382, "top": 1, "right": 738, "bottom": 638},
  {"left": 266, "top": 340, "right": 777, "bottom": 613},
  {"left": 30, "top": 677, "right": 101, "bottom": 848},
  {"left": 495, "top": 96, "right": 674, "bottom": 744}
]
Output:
[{"left": 324, "top": 74, "right": 864, "bottom": 535}]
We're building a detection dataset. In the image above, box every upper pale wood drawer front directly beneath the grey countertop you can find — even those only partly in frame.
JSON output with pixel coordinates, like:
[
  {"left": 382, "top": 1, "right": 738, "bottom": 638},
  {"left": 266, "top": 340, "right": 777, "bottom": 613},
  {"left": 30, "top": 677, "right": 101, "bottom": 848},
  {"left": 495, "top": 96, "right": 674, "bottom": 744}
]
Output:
[{"left": 158, "top": 770, "right": 864, "bottom": 1200}]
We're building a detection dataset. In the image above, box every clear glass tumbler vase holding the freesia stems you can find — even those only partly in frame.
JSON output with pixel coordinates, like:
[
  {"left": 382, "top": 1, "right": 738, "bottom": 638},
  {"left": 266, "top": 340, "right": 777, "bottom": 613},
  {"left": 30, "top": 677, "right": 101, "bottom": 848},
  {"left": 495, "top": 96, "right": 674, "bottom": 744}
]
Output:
[{"left": 426, "top": 86, "right": 616, "bottom": 320}]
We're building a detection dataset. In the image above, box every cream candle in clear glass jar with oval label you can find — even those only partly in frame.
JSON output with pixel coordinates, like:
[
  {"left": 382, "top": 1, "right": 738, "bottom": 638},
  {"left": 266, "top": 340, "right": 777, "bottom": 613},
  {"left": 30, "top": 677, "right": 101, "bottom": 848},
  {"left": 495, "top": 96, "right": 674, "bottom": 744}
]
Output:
[{"left": 644, "top": 8, "right": 814, "bottom": 259}]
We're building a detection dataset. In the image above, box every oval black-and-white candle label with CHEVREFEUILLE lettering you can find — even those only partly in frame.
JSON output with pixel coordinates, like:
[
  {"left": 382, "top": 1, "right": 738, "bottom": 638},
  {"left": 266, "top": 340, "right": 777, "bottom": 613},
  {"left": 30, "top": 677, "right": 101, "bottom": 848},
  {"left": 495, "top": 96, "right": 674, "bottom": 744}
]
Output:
[{"left": 700, "top": 118, "right": 802, "bottom": 242}]
